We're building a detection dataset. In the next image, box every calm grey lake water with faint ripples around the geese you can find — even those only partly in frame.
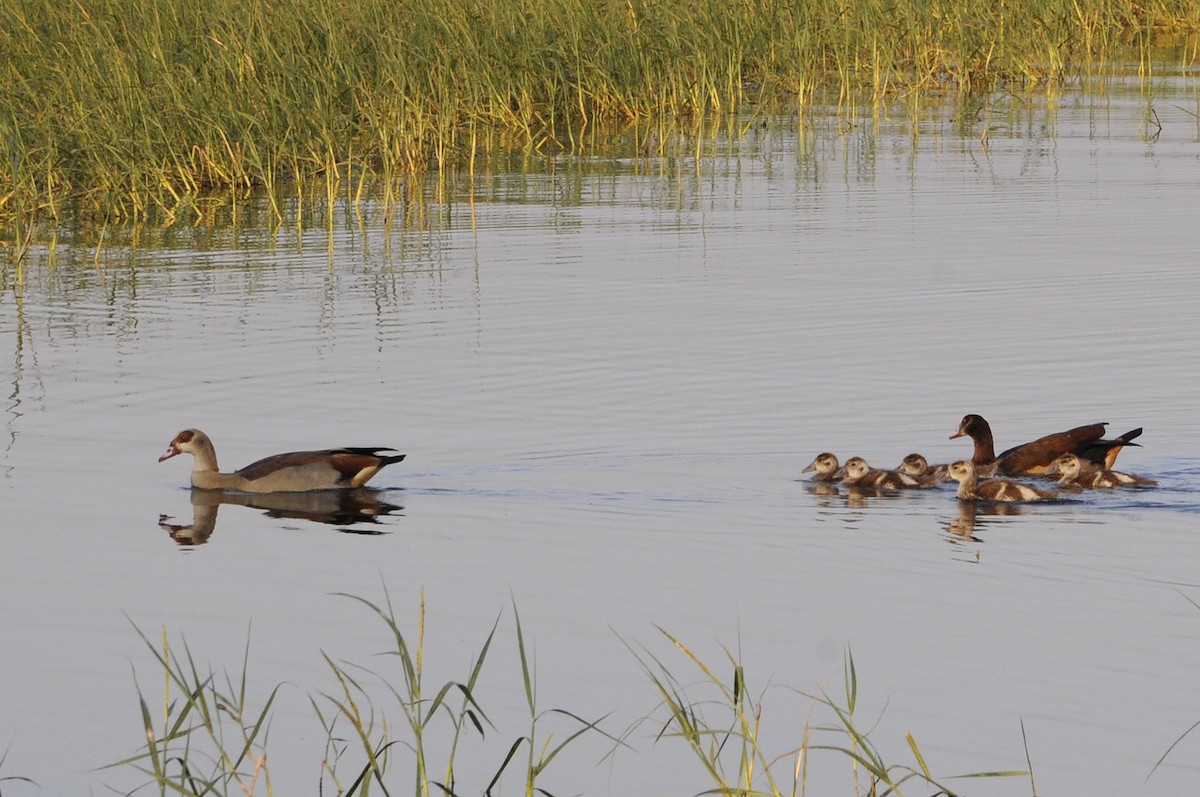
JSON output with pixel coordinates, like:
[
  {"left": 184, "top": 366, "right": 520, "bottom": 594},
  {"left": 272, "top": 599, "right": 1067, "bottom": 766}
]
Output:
[{"left": 7, "top": 77, "right": 1200, "bottom": 795}]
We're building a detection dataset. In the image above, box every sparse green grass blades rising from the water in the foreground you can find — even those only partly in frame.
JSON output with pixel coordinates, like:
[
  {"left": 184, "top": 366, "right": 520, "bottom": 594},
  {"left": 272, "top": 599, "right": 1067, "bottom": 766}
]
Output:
[{"left": 104, "top": 591, "right": 1037, "bottom": 797}]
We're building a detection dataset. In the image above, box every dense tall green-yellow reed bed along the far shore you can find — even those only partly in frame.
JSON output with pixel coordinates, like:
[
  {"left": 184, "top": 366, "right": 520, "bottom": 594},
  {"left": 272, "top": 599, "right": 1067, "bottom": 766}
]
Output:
[{"left": 0, "top": 0, "right": 1200, "bottom": 225}]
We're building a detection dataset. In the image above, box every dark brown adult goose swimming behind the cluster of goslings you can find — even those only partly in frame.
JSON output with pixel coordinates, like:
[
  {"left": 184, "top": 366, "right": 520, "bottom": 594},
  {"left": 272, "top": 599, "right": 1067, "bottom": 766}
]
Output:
[{"left": 950, "top": 415, "right": 1141, "bottom": 475}]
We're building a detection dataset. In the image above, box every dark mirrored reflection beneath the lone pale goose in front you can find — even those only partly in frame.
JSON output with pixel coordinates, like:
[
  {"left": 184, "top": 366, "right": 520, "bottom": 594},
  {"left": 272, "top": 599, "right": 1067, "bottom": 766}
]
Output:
[{"left": 158, "top": 490, "right": 404, "bottom": 545}]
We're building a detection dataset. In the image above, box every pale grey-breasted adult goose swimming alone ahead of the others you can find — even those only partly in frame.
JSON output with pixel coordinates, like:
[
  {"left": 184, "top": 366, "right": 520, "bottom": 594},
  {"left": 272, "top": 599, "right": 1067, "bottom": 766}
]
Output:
[{"left": 158, "top": 429, "right": 404, "bottom": 492}]
